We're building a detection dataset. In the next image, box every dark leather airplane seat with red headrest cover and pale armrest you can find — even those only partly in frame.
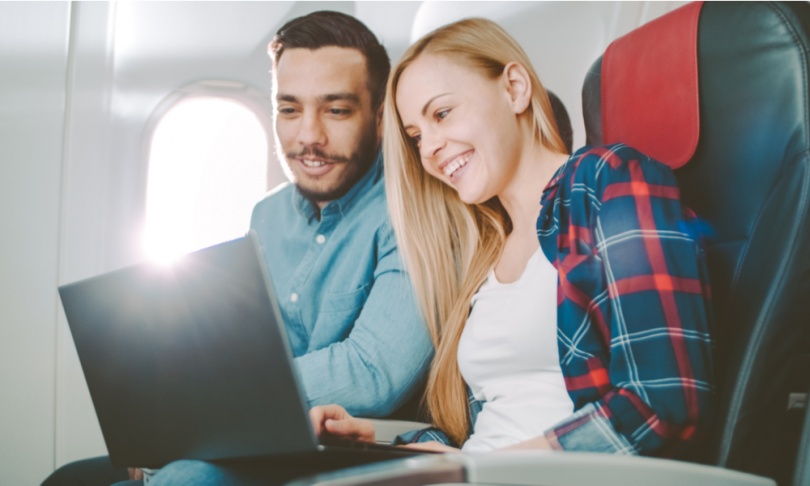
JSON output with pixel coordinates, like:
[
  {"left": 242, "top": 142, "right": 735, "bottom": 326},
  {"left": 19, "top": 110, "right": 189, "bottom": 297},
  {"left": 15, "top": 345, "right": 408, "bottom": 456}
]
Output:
[{"left": 288, "top": 2, "right": 810, "bottom": 486}]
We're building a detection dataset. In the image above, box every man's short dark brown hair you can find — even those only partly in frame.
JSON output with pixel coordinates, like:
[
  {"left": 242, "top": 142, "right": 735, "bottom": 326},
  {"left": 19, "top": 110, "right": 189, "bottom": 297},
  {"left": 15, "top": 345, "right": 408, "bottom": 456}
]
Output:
[{"left": 270, "top": 10, "right": 391, "bottom": 110}]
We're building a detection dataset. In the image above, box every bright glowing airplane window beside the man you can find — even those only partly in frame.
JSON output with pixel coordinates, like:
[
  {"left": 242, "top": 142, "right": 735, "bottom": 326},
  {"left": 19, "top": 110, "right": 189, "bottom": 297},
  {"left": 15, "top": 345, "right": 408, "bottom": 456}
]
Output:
[{"left": 144, "top": 96, "right": 268, "bottom": 262}]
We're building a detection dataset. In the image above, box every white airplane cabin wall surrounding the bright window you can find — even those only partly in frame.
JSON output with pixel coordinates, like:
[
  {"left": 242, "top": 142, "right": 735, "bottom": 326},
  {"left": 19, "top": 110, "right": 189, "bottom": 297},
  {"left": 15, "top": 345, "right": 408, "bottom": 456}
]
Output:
[{"left": 0, "top": 2, "right": 684, "bottom": 485}]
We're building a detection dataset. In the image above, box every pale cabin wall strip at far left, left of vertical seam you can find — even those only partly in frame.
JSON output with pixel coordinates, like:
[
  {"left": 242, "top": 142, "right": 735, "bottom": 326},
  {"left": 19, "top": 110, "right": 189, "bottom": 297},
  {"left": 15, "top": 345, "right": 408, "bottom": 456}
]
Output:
[{"left": 0, "top": 3, "right": 70, "bottom": 485}]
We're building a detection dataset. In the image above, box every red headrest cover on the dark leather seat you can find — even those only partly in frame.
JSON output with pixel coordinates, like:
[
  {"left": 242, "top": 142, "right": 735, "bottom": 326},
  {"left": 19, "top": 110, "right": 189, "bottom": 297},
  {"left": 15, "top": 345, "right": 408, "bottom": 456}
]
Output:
[{"left": 602, "top": 2, "right": 703, "bottom": 169}]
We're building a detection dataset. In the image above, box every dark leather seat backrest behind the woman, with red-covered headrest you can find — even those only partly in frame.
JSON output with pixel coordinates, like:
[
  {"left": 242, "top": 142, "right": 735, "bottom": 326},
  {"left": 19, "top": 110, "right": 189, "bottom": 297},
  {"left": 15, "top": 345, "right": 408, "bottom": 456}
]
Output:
[{"left": 583, "top": 2, "right": 810, "bottom": 484}]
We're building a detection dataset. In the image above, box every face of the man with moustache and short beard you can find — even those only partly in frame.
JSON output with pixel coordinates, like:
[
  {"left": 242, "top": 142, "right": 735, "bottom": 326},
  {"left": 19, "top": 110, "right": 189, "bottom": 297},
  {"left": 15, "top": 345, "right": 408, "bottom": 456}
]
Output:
[{"left": 275, "top": 46, "right": 380, "bottom": 207}]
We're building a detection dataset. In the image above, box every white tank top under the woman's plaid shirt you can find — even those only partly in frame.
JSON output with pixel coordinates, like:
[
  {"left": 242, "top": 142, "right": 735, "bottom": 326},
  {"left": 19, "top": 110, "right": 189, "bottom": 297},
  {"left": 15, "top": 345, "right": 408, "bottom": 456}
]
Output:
[{"left": 458, "top": 249, "right": 574, "bottom": 452}]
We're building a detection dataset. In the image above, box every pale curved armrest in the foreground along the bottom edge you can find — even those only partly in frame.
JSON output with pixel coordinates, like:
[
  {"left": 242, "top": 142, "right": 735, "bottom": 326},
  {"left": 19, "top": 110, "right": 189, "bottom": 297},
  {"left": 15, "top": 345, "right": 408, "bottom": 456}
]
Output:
[{"left": 294, "top": 451, "right": 776, "bottom": 486}]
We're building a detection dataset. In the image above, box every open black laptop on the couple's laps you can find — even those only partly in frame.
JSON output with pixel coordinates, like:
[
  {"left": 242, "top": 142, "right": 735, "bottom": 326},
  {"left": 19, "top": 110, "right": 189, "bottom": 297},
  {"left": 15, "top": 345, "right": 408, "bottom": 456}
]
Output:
[{"left": 59, "top": 232, "right": 420, "bottom": 468}]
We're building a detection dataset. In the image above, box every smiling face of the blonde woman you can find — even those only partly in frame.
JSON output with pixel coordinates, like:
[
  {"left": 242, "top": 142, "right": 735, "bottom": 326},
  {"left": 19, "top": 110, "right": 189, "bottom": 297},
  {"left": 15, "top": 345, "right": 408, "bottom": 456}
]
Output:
[{"left": 395, "top": 54, "right": 520, "bottom": 204}]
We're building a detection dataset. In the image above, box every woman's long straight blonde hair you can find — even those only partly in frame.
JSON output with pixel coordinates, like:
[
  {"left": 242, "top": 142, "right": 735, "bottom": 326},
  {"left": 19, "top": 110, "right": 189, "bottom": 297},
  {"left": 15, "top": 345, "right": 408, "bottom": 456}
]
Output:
[{"left": 383, "top": 18, "right": 565, "bottom": 445}]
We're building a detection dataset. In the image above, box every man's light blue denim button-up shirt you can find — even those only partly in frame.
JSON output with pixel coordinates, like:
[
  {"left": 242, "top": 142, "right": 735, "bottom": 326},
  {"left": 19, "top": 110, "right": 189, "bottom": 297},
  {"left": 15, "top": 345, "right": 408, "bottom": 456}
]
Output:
[{"left": 250, "top": 157, "right": 433, "bottom": 416}]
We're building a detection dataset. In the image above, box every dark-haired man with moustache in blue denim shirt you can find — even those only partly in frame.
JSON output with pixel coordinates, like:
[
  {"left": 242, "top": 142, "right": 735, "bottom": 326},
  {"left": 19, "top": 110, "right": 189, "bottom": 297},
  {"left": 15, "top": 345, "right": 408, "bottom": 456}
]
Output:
[{"left": 44, "top": 12, "right": 433, "bottom": 485}]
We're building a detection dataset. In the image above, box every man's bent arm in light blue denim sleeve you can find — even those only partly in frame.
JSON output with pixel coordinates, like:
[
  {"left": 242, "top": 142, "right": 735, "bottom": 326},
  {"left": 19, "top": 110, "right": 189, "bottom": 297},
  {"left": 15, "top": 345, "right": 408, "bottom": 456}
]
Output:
[{"left": 295, "top": 224, "right": 433, "bottom": 417}]
